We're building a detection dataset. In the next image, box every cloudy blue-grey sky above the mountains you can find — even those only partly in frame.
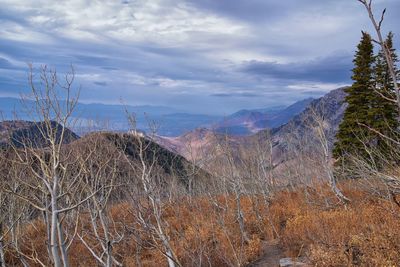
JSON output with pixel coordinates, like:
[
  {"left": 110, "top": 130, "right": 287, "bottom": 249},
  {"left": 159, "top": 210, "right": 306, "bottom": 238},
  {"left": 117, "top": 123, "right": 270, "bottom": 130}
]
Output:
[{"left": 0, "top": 0, "right": 400, "bottom": 115}]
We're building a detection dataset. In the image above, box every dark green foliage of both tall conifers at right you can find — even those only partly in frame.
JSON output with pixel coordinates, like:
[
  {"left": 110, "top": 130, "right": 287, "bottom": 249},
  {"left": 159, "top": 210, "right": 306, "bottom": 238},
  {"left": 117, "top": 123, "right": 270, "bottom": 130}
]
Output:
[{"left": 333, "top": 32, "right": 399, "bottom": 168}]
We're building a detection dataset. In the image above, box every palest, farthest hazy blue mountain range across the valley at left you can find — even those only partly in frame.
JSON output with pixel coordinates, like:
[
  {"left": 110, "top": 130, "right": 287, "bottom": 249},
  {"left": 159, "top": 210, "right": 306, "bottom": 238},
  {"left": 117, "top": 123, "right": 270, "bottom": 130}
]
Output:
[{"left": 0, "top": 97, "right": 222, "bottom": 136}]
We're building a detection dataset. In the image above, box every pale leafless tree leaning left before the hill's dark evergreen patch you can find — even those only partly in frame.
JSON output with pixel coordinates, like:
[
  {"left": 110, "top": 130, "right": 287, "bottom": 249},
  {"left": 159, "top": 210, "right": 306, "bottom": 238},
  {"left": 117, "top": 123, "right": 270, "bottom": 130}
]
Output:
[{"left": 122, "top": 114, "right": 181, "bottom": 267}]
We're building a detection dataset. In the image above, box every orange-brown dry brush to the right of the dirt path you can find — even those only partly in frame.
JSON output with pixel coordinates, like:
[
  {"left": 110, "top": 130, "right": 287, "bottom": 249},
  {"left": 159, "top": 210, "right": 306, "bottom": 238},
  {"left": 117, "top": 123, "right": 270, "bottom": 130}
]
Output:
[{"left": 272, "top": 186, "right": 400, "bottom": 266}]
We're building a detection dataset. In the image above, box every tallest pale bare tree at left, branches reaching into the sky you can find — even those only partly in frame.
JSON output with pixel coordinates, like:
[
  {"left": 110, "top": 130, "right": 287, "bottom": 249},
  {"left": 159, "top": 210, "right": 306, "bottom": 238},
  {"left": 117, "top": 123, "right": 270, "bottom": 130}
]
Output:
[{"left": 4, "top": 66, "right": 91, "bottom": 267}]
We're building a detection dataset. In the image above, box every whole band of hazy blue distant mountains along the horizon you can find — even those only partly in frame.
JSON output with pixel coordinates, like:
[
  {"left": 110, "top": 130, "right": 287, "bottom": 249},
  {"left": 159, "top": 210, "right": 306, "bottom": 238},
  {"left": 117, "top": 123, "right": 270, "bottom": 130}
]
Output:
[{"left": 0, "top": 97, "right": 312, "bottom": 137}]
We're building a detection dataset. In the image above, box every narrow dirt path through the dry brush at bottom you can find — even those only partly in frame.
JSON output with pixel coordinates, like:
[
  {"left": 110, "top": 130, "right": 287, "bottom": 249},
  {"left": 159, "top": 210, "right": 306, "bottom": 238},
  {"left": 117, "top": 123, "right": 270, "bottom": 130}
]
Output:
[{"left": 247, "top": 240, "right": 285, "bottom": 267}]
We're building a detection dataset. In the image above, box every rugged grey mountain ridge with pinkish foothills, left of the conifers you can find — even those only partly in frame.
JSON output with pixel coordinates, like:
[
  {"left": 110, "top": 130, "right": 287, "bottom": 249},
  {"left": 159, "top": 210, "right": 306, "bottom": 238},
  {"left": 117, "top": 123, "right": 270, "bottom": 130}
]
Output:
[{"left": 157, "top": 87, "right": 346, "bottom": 164}]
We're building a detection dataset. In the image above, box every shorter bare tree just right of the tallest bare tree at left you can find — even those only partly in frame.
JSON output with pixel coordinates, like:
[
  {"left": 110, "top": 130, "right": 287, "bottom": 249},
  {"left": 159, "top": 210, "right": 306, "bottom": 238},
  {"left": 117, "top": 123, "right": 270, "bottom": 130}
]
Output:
[{"left": 76, "top": 134, "right": 124, "bottom": 267}]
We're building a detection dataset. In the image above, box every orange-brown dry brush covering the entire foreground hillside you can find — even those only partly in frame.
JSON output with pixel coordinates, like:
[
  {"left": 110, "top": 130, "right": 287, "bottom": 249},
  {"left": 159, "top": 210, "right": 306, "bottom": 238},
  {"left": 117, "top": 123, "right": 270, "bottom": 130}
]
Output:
[{"left": 3, "top": 184, "right": 400, "bottom": 266}]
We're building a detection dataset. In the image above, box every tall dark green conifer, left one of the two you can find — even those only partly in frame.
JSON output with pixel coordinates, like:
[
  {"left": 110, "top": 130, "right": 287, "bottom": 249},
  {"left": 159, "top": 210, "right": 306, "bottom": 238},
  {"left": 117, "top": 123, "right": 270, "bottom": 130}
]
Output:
[{"left": 333, "top": 32, "right": 376, "bottom": 162}]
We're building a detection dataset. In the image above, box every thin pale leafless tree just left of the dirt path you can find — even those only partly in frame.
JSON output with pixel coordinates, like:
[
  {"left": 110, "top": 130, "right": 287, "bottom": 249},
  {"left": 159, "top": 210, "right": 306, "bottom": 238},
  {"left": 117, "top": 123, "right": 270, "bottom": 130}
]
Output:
[{"left": 203, "top": 134, "right": 253, "bottom": 266}]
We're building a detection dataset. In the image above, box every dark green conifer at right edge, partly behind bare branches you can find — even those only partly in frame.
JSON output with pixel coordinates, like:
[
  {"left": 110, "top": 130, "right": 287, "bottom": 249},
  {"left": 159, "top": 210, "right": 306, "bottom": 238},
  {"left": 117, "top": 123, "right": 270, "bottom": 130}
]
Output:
[{"left": 371, "top": 32, "right": 399, "bottom": 156}]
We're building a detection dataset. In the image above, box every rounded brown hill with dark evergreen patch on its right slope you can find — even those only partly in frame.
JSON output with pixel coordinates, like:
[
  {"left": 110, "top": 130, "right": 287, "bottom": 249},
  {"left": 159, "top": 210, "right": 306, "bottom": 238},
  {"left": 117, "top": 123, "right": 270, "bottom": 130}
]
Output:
[{"left": 68, "top": 132, "right": 212, "bottom": 189}]
